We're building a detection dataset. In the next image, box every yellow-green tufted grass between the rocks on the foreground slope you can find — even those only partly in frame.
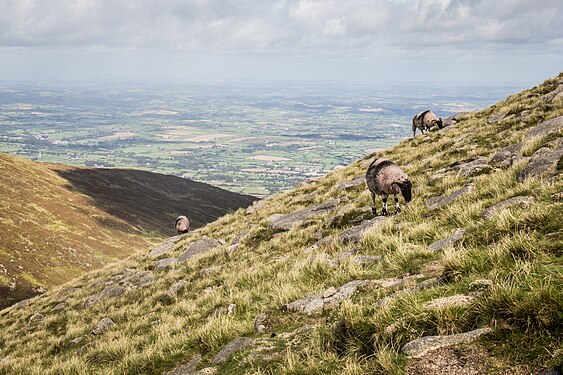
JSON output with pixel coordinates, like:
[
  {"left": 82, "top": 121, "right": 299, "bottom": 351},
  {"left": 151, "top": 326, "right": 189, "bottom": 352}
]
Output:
[{"left": 0, "top": 75, "right": 563, "bottom": 374}]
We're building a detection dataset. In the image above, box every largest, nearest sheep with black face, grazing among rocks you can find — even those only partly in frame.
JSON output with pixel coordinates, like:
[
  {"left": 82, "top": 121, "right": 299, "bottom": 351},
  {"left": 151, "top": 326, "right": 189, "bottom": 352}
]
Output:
[{"left": 366, "top": 158, "right": 412, "bottom": 216}]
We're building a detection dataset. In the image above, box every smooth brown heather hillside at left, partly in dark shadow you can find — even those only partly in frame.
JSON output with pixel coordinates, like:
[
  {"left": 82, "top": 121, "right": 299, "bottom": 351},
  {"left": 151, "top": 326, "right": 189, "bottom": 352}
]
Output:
[{"left": 0, "top": 154, "right": 253, "bottom": 308}]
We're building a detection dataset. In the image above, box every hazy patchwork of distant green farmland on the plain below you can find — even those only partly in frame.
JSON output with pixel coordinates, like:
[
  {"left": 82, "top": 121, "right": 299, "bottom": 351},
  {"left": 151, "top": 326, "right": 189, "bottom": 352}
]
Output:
[{"left": 0, "top": 82, "right": 517, "bottom": 196}]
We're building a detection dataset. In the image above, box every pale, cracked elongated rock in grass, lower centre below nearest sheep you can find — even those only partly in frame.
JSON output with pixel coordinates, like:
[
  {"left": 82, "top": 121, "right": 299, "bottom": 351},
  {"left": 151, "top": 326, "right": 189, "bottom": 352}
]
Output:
[{"left": 284, "top": 280, "right": 370, "bottom": 315}]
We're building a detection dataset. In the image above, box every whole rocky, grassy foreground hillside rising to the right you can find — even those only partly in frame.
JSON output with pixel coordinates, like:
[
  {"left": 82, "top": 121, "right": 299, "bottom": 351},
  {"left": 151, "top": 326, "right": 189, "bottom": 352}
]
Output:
[{"left": 0, "top": 74, "right": 563, "bottom": 374}]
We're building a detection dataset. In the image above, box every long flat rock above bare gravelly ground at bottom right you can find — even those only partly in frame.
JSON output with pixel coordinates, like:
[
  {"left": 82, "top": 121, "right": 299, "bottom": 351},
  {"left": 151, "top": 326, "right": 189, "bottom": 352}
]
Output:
[{"left": 401, "top": 327, "right": 492, "bottom": 358}]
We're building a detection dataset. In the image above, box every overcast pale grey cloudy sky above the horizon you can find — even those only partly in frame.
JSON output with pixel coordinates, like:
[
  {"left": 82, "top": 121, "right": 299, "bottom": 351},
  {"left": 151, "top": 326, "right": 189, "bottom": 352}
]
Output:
[{"left": 0, "top": 0, "right": 563, "bottom": 83}]
